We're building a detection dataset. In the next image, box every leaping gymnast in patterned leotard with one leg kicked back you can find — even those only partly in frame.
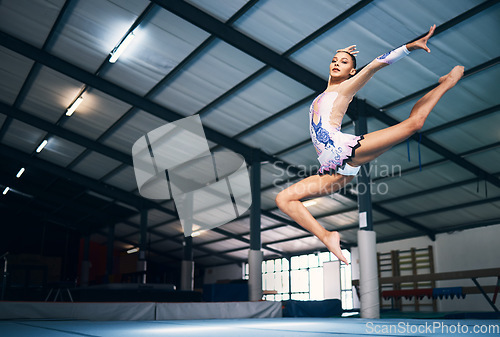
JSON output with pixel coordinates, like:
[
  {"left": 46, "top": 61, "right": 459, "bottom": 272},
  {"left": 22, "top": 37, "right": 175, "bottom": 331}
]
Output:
[{"left": 276, "top": 25, "right": 464, "bottom": 264}]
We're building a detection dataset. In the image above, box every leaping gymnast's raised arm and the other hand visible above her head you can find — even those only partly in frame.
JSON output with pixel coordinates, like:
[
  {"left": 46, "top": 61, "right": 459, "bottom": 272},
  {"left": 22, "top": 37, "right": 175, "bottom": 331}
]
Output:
[{"left": 338, "top": 25, "right": 436, "bottom": 98}]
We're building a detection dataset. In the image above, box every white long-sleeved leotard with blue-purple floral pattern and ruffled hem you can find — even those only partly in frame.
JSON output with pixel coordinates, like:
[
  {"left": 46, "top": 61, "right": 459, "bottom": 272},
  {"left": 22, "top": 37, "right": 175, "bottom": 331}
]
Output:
[{"left": 309, "top": 91, "right": 363, "bottom": 174}]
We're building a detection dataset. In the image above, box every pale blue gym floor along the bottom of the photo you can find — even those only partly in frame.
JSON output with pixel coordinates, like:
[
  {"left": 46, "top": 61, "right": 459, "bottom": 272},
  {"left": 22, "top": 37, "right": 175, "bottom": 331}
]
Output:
[{"left": 0, "top": 318, "right": 500, "bottom": 337}]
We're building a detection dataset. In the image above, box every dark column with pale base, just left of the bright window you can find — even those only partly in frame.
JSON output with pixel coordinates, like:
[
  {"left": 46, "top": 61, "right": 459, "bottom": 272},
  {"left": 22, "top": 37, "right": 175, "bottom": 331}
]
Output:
[{"left": 248, "top": 151, "right": 263, "bottom": 301}]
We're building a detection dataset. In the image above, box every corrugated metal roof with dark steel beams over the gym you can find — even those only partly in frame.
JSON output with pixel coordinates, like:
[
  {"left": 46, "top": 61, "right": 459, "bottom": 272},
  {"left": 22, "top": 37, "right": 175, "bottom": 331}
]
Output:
[{"left": 0, "top": 0, "right": 500, "bottom": 265}]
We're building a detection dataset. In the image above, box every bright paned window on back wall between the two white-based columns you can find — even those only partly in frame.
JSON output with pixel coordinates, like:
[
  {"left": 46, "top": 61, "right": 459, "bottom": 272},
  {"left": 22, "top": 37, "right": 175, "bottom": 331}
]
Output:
[{"left": 245, "top": 250, "right": 353, "bottom": 309}]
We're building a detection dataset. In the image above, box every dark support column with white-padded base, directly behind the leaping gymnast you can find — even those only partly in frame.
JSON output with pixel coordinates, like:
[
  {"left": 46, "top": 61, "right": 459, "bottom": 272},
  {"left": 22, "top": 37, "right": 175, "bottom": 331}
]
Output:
[{"left": 354, "top": 101, "right": 380, "bottom": 318}]
